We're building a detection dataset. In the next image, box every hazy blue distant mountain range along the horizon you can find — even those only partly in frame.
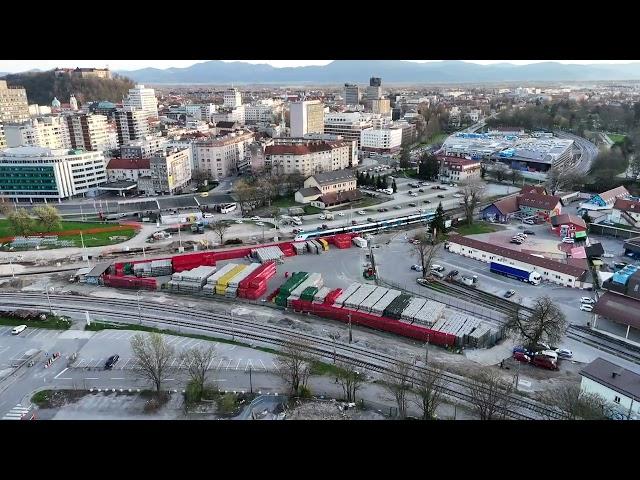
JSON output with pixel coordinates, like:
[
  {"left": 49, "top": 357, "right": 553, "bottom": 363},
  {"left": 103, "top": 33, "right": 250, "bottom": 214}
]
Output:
[{"left": 112, "top": 60, "right": 640, "bottom": 84}]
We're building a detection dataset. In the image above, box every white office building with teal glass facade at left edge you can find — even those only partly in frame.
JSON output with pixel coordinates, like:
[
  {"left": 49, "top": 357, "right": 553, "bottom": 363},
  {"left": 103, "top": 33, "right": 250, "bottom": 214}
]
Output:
[{"left": 0, "top": 147, "right": 107, "bottom": 202}]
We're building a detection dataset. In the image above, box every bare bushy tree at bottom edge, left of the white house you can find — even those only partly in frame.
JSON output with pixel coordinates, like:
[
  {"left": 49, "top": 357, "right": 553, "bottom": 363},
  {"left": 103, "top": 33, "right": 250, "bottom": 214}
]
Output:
[{"left": 542, "top": 385, "right": 607, "bottom": 420}]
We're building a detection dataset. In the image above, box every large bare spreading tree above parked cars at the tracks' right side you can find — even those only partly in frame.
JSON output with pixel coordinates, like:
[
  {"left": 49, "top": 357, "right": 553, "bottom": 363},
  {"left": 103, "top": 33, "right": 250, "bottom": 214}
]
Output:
[{"left": 506, "top": 296, "right": 567, "bottom": 348}]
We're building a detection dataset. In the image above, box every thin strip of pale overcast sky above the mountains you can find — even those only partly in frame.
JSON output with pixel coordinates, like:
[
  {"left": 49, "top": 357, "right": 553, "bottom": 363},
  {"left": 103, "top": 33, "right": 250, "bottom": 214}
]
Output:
[{"left": 0, "top": 60, "right": 638, "bottom": 72}]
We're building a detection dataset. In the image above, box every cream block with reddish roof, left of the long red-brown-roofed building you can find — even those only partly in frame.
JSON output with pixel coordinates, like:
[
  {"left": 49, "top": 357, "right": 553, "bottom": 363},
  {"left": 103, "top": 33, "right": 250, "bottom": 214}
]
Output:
[{"left": 192, "top": 131, "right": 254, "bottom": 180}]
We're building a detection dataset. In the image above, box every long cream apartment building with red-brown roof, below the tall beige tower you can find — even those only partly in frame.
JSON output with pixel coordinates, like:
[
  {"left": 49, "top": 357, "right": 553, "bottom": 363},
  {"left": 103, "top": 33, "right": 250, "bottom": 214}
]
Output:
[{"left": 265, "top": 140, "right": 357, "bottom": 176}]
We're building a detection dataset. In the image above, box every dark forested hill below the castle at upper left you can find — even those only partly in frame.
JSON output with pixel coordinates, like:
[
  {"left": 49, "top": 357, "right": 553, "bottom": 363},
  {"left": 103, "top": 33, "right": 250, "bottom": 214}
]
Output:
[{"left": 4, "top": 70, "right": 134, "bottom": 105}]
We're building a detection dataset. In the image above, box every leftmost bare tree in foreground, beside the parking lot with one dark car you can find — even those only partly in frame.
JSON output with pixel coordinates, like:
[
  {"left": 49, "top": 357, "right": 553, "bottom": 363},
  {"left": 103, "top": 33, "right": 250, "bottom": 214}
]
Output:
[{"left": 131, "top": 333, "right": 176, "bottom": 393}]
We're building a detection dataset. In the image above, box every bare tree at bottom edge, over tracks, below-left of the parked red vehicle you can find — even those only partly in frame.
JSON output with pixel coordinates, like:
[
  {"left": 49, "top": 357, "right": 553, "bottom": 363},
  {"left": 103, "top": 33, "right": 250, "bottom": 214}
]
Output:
[{"left": 467, "top": 370, "right": 513, "bottom": 420}]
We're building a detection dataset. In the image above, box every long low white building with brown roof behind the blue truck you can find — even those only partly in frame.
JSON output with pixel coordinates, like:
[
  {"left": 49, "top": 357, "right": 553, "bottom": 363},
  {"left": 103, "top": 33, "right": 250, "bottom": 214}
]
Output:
[{"left": 448, "top": 235, "right": 592, "bottom": 288}]
